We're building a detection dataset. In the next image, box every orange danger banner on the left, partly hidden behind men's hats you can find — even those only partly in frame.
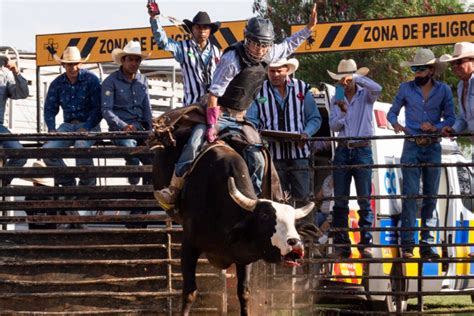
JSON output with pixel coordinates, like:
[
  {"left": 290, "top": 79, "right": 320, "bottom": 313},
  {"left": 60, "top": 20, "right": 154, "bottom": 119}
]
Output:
[{"left": 36, "top": 21, "right": 246, "bottom": 66}]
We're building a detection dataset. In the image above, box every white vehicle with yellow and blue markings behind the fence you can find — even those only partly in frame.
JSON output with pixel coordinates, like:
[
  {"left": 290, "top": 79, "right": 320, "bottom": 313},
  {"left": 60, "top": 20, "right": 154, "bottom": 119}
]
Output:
[{"left": 315, "top": 85, "right": 474, "bottom": 311}]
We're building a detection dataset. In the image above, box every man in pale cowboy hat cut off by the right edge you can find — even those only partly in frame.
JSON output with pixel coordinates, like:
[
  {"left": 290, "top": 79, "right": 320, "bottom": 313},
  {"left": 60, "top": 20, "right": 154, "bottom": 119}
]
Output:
[{"left": 440, "top": 42, "right": 474, "bottom": 136}]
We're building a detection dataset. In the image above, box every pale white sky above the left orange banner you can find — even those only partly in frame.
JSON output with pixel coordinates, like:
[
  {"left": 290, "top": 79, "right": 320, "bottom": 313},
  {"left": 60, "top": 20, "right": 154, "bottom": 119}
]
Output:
[{"left": 0, "top": 0, "right": 253, "bottom": 52}]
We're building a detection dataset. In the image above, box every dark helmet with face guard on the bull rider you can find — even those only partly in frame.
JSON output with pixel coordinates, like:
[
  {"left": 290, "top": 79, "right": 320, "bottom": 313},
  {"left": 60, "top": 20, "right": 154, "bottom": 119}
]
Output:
[{"left": 244, "top": 17, "right": 275, "bottom": 62}]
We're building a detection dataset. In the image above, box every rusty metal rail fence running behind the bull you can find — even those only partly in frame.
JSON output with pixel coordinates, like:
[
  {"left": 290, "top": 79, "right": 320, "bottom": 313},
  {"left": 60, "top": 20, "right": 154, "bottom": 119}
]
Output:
[{"left": 0, "top": 133, "right": 474, "bottom": 315}]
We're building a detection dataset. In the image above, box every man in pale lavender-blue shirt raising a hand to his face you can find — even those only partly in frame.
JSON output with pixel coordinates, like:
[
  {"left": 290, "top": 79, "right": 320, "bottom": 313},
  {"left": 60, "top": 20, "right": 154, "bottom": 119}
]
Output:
[{"left": 328, "top": 59, "right": 382, "bottom": 258}]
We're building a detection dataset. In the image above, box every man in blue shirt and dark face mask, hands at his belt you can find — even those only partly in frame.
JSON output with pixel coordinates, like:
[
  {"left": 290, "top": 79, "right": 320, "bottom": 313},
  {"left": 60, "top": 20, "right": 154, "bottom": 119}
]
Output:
[{"left": 387, "top": 48, "right": 455, "bottom": 258}]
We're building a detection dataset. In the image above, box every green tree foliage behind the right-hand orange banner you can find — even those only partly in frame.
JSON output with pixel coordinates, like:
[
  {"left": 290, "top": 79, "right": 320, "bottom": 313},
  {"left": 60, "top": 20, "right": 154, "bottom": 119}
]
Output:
[{"left": 254, "top": 0, "right": 463, "bottom": 103}]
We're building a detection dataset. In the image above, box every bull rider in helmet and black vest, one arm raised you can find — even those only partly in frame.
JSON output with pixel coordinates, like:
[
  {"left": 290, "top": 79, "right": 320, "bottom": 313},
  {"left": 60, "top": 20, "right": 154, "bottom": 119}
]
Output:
[{"left": 155, "top": 5, "right": 317, "bottom": 209}]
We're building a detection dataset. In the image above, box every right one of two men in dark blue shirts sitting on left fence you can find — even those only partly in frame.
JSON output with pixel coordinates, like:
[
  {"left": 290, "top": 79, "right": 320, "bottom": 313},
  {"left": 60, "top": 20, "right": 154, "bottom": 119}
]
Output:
[{"left": 102, "top": 41, "right": 152, "bottom": 184}]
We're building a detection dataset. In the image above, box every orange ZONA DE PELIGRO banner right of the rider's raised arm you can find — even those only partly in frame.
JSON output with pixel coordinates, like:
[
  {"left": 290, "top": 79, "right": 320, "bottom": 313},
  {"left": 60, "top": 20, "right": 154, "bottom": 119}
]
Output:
[{"left": 291, "top": 13, "right": 474, "bottom": 53}]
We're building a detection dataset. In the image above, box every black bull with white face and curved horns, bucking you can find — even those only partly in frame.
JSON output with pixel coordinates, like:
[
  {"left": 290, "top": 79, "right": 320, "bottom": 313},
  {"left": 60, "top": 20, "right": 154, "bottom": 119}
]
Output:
[{"left": 154, "top": 146, "right": 314, "bottom": 315}]
